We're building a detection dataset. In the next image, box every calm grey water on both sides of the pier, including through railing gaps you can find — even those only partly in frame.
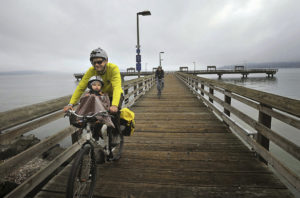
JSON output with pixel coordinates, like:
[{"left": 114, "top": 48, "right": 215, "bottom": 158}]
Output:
[{"left": 0, "top": 68, "right": 300, "bottom": 174}]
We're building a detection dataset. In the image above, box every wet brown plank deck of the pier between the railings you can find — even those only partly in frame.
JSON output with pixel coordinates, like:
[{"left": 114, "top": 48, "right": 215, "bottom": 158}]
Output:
[{"left": 36, "top": 75, "right": 293, "bottom": 198}]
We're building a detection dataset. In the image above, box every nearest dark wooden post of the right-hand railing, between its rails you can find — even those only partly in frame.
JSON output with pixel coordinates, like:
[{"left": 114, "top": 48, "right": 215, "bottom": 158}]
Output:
[{"left": 256, "top": 103, "right": 272, "bottom": 164}]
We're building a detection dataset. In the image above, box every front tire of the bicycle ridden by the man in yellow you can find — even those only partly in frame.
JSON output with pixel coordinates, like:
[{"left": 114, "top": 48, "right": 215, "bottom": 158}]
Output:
[{"left": 66, "top": 144, "right": 96, "bottom": 198}]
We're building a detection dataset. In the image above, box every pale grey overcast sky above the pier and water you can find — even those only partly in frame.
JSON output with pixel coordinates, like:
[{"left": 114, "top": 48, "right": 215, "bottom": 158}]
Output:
[{"left": 0, "top": 0, "right": 300, "bottom": 73}]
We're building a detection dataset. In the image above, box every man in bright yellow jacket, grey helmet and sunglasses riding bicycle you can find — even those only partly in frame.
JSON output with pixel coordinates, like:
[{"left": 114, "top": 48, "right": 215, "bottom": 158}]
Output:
[{"left": 64, "top": 48, "right": 123, "bottom": 144}]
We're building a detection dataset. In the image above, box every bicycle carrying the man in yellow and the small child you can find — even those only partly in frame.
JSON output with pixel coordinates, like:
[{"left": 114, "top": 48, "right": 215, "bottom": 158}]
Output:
[{"left": 66, "top": 110, "right": 124, "bottom": 198}]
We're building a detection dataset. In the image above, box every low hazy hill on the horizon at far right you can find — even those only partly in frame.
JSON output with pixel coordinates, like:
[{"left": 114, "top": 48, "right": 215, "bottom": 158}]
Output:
[{"left": 219, "top": 62, "right": 300, "bottom": 69}]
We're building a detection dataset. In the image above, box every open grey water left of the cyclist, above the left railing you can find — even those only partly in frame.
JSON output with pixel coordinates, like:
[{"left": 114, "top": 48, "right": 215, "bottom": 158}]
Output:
[{"left": 0, "top": 74, "right": 78, "bottom": 112}]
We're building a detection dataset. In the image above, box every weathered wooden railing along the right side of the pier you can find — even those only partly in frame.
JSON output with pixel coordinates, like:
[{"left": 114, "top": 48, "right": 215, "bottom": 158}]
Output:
[{"left": 176, "top": 72, "right": 300, "bottom": 191}]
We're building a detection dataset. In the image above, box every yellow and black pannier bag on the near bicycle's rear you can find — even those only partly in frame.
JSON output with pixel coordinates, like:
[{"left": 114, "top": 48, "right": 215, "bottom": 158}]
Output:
[{"left": 120, "top": 108, "right": 135, "bottom": 136}]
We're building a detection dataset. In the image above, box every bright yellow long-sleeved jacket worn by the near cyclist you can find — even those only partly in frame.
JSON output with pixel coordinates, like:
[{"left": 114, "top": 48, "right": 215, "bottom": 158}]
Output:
[{"left": 70, "top": 63, "right": 123, "bottom": 106}]
